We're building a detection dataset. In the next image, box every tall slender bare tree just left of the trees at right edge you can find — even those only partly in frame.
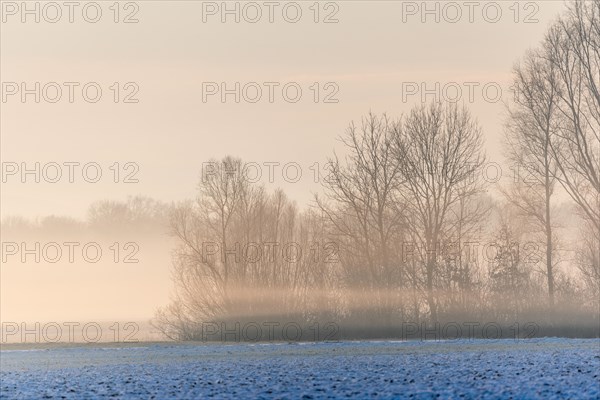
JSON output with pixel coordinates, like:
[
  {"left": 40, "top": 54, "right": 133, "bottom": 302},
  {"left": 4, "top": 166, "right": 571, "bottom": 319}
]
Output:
[{"left": 503, "top": 48, "right": 560, "bottom": 305}]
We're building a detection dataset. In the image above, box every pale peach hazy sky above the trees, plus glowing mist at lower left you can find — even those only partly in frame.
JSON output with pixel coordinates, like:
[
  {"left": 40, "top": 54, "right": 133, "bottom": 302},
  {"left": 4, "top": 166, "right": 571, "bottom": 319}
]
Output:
[{"left": 0, "top": 1, "right": 564, "bottom": 320}]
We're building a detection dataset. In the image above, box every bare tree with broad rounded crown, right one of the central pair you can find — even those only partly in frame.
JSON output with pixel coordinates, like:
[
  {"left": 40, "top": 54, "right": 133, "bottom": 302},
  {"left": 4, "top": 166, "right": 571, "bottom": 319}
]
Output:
[{"left": 394, "top": 103, "right": 484, "bottom": 321}]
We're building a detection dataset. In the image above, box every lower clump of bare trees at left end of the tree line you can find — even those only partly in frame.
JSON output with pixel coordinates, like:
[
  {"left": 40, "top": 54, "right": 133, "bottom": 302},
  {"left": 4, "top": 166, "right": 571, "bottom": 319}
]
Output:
[{"left": 156, "top": 157, "right": 335, "bottom": 340}]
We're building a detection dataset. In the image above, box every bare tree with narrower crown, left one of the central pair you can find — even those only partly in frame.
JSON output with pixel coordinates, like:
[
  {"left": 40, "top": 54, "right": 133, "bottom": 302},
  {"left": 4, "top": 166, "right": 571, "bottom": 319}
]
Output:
[{"left": 316, "top": 113, "right": 402, "bottom": 318}]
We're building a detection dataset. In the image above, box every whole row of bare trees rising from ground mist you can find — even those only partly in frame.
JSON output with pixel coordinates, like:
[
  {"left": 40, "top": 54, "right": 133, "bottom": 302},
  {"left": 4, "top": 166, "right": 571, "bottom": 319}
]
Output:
[{"left": 156, "top": 1, "right": 600, "bottom": 340}]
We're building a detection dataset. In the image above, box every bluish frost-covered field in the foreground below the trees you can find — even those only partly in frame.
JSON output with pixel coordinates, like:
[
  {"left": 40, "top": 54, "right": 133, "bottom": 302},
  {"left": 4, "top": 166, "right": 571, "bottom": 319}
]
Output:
[{"left": 0, "top": 339, "right": 600, "bottom": 399}]
